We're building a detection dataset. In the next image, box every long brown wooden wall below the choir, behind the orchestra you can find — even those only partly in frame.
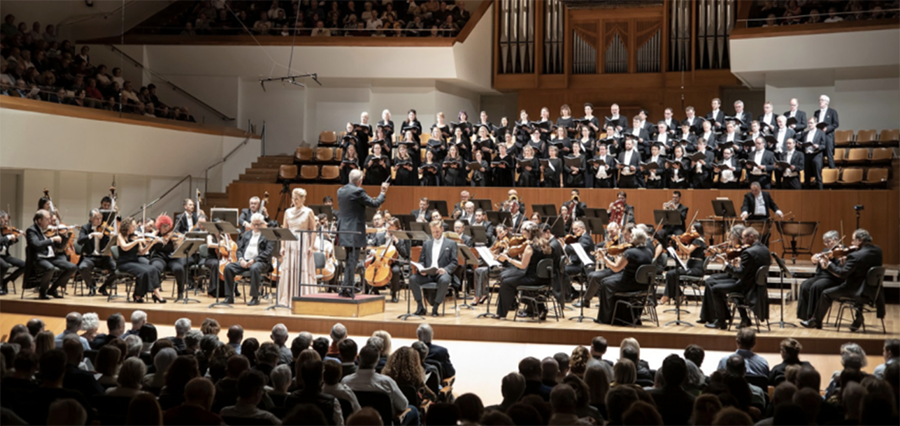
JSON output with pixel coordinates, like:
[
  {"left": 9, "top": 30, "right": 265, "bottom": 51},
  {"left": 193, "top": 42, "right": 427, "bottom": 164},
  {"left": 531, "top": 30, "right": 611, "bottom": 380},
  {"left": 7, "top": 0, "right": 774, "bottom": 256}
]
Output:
[{"left": 228, "top": 182, "right": 900, "bottom": 264}]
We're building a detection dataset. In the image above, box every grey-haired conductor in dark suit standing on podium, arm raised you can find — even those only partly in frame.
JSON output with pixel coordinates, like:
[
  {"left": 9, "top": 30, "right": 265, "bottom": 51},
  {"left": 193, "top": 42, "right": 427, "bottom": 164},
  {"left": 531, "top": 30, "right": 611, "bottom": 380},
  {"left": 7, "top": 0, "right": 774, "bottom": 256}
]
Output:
[{"left": 337, "top": 169, "right": 390, "bottom": 299}]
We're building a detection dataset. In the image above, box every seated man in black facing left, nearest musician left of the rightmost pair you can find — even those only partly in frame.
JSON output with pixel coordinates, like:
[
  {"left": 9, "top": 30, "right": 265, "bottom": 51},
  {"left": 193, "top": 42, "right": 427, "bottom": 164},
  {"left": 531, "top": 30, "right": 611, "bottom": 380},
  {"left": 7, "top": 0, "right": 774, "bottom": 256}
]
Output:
[{"left": 706, "top": 227, "right": 770, "bottom": 330}]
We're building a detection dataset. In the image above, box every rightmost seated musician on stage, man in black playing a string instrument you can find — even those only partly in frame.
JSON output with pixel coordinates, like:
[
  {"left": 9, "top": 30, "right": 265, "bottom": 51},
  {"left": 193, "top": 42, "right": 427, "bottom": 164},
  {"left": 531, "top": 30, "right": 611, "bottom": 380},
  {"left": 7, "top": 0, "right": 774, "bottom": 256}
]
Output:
[{"left": 800, "top": 229, "right": 884, "bottom": 331}]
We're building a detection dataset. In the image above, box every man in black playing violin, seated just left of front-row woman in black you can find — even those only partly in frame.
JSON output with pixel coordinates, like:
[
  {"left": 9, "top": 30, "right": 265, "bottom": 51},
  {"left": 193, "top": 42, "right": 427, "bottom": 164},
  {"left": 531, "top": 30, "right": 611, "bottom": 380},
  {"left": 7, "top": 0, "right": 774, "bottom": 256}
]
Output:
[{"left": 78, "top": 209, "right": 116, "bottom": 296}]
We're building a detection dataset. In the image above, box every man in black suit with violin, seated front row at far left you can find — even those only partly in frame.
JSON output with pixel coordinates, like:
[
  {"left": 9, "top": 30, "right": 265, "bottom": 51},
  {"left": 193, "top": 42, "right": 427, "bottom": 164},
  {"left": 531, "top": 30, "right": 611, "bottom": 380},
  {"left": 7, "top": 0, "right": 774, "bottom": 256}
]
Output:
[{"left": 25, "top": 210, "right": 77, "bottom": 300}]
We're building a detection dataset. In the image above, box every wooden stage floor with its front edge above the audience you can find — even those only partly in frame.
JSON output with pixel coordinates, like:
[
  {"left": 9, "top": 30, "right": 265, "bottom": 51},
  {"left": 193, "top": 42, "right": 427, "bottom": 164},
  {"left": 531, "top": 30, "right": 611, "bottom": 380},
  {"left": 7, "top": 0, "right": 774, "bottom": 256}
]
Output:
[{"left": 0, "top": 281, "right": 900, "bottom": 355}]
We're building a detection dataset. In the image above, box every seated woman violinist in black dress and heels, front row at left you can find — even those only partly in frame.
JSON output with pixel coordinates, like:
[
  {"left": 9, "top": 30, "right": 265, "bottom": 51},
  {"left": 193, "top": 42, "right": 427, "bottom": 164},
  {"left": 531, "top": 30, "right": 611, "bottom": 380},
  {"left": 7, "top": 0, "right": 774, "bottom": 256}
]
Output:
[{"left": 116, "top": 217, "right": 166, "bottom": 303}]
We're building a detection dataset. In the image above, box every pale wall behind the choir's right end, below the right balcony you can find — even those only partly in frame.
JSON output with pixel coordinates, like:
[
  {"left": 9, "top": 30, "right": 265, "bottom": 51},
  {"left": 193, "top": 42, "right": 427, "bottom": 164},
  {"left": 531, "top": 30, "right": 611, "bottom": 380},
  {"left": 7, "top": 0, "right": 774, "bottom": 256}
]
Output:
[{"left": 766, "top": 78, "right": 900, "bottom": 131}]
